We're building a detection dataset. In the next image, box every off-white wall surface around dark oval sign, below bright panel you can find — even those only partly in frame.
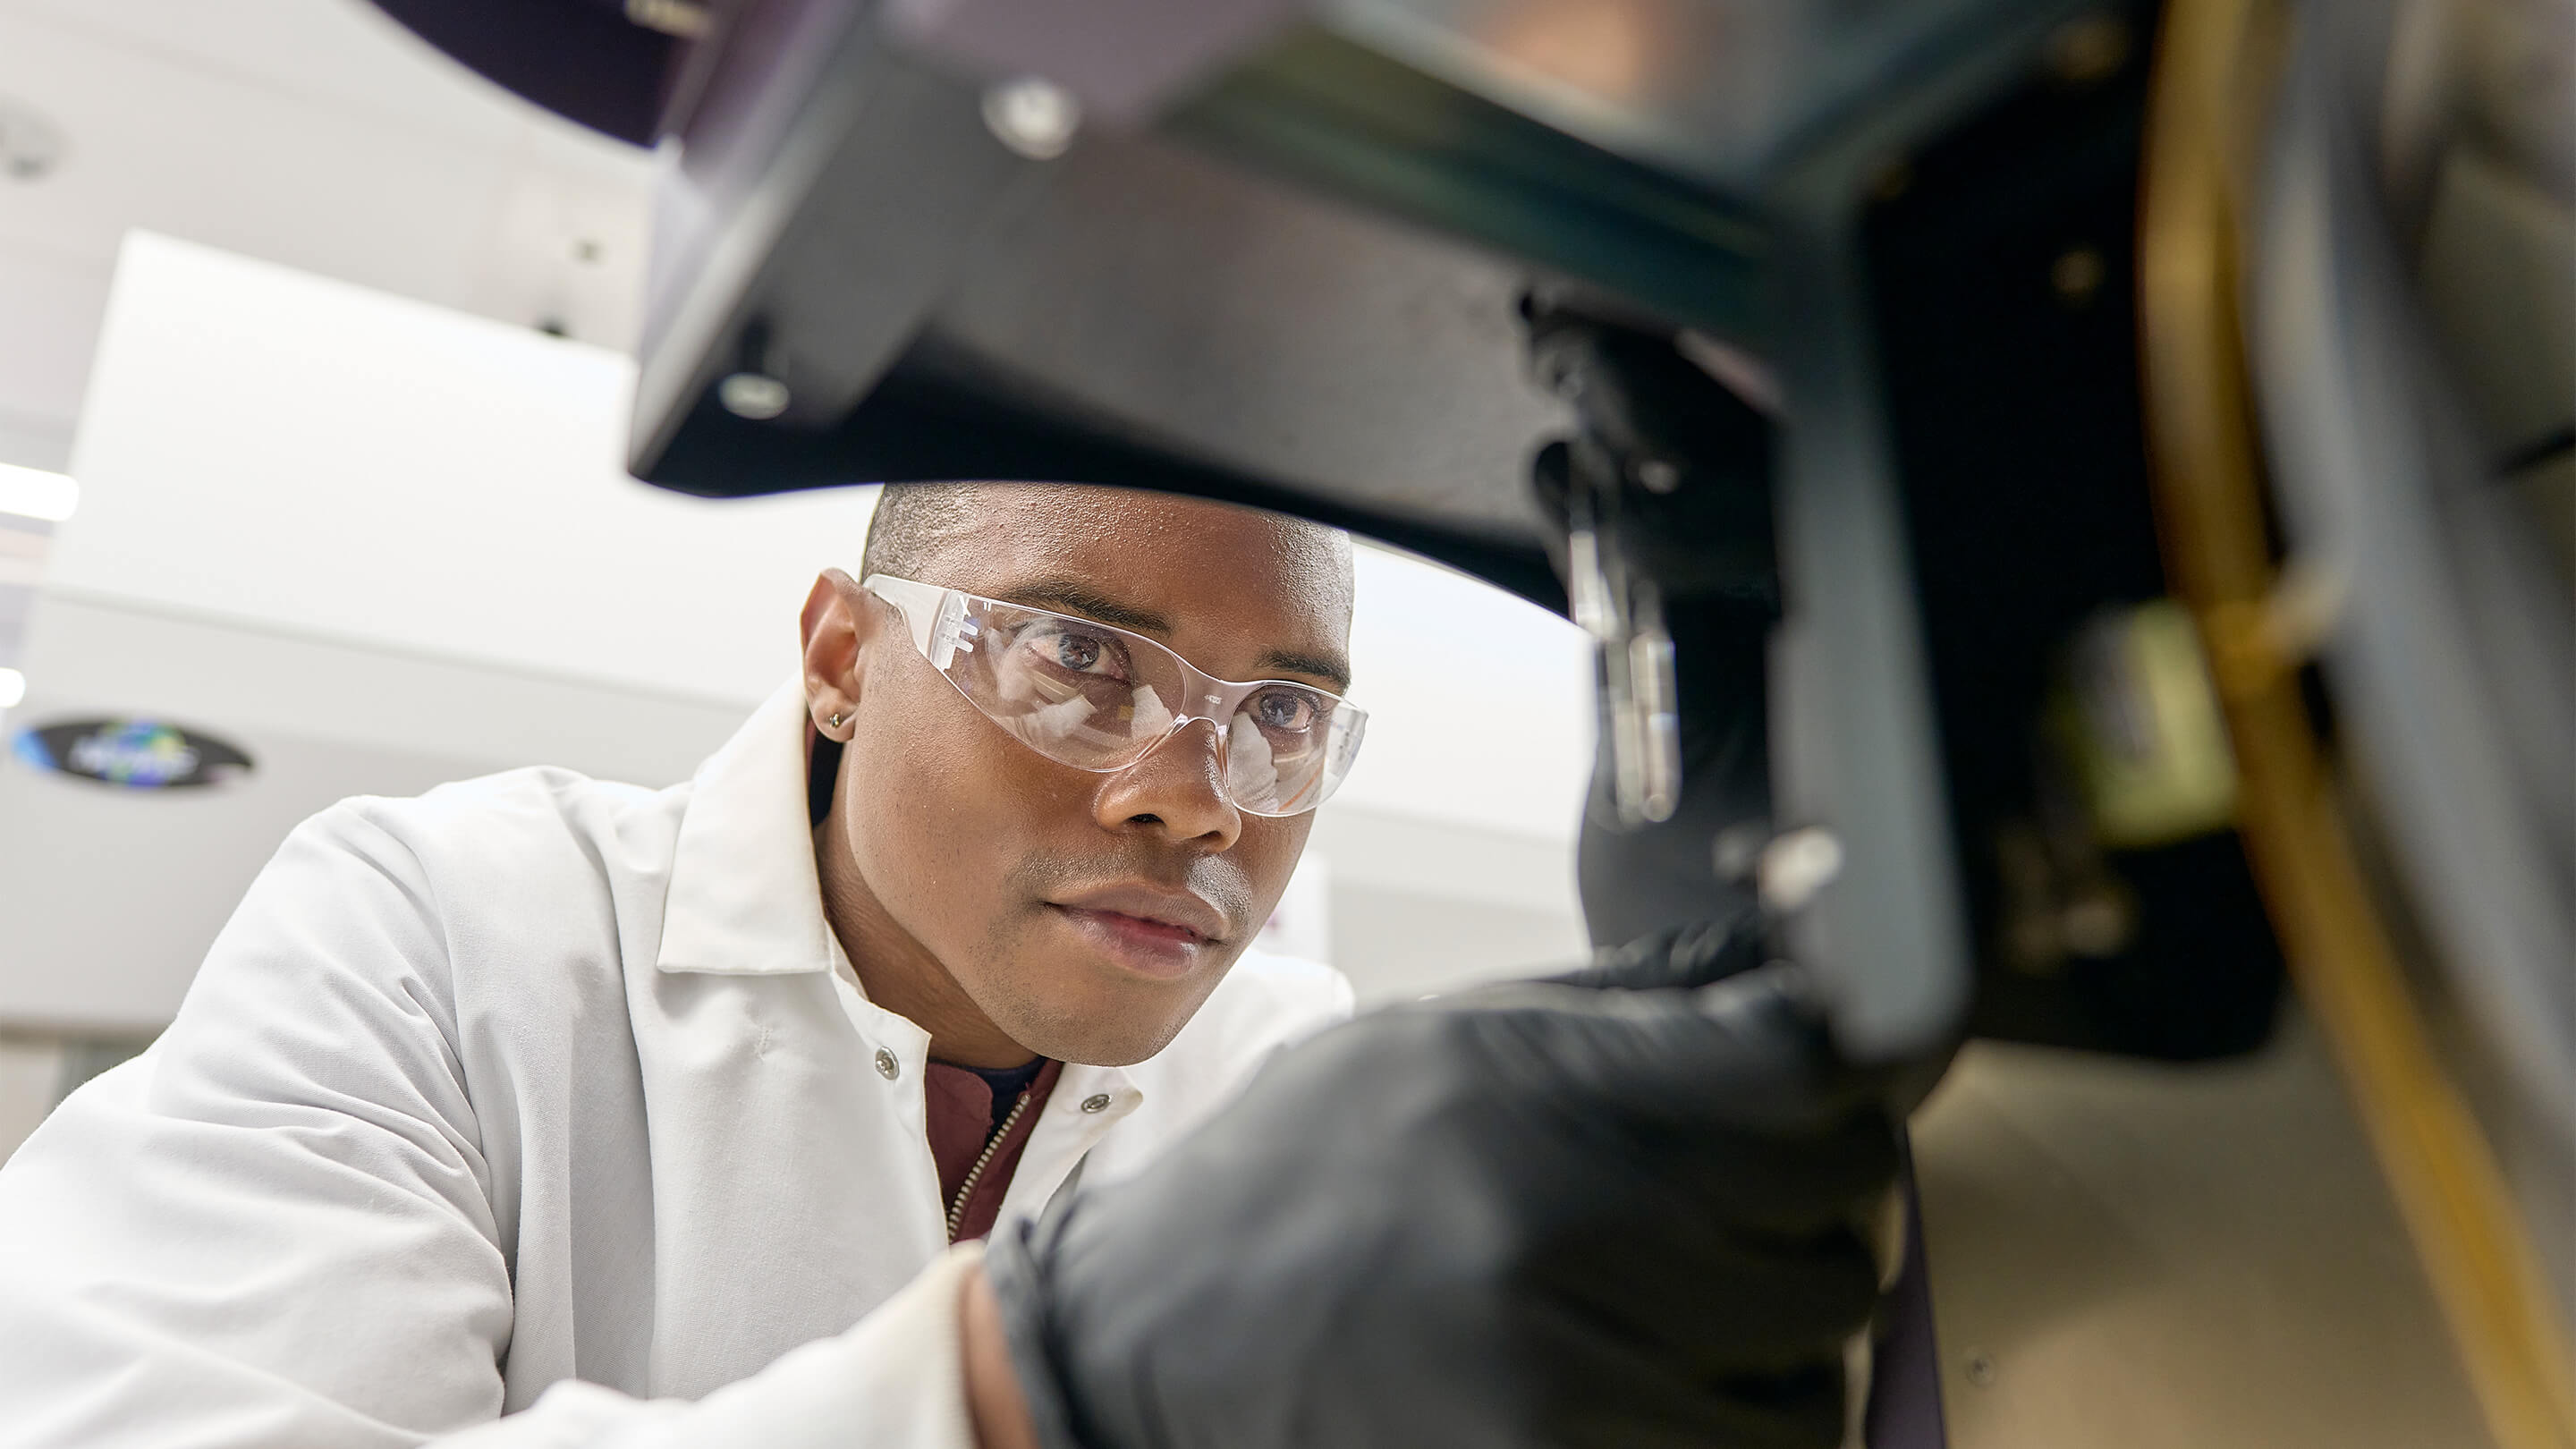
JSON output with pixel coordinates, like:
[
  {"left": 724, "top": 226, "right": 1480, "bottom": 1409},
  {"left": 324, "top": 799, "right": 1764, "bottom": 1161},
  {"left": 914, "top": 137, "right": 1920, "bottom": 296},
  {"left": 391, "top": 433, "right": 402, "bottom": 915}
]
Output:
[{"left": 0, "top": 596, "right": 741, "bottom": 1037}]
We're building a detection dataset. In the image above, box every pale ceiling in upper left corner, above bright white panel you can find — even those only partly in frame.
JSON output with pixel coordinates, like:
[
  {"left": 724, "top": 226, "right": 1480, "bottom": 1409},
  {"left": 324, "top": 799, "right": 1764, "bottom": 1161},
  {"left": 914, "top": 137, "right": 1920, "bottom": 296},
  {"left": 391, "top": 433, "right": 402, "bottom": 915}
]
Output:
[{"left": 0, "top": 0, "right": 652, "bottom": 470}]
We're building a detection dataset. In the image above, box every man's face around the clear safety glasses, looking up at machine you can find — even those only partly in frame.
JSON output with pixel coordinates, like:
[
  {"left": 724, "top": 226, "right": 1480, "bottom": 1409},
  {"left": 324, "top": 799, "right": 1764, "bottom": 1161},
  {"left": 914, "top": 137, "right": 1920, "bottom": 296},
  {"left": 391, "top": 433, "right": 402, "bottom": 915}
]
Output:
[{"left": 826, "top": 487, "right": 1352, "bottom": 1064}]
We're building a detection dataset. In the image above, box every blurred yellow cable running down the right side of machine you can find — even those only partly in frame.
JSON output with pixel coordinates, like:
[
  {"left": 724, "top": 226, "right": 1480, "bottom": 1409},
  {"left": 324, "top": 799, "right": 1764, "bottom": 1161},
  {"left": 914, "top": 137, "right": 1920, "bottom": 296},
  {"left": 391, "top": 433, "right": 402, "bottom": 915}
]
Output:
[{"left": 2138, "top": 0, "right": 2576, "bottom": 1449}]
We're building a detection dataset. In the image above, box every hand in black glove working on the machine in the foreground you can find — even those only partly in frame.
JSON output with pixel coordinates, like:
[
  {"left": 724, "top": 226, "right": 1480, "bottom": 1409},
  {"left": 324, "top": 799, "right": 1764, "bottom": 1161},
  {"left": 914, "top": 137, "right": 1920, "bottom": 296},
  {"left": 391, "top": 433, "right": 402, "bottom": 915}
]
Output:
[{"left": 984, "top": 912, "right": 1899, "bottom": 1449}]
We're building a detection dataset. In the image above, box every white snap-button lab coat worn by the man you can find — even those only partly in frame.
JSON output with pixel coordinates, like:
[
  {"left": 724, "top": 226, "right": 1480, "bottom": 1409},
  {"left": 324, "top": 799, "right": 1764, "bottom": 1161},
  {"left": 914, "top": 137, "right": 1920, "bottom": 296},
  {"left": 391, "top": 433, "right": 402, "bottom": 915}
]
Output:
[{"left": 0, "top": 689, "right": 1350, "bottom": 1449}]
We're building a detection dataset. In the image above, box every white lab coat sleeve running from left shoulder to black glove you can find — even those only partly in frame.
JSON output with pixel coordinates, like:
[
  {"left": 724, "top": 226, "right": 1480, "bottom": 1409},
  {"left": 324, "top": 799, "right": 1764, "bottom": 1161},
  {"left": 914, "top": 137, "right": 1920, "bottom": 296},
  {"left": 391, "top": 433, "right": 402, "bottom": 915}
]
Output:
[{"left": 0, "top": 804, "right": 971, "bottom": 1449}]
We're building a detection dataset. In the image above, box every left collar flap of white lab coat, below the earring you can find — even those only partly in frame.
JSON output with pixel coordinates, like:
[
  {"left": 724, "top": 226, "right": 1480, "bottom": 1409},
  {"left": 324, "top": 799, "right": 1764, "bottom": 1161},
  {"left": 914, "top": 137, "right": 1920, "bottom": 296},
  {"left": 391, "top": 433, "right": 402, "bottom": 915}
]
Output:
[{"left": 655, "top": 678, "right": 837, "bottom": 975}]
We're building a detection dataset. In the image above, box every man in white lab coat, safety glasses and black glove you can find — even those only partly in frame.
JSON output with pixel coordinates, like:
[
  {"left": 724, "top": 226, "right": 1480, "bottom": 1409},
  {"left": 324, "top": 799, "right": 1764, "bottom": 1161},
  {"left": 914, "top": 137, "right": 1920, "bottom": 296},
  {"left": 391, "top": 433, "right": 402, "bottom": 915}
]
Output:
[{"left": 0, "top": 485, "right": 1885, "bottom": 1449}]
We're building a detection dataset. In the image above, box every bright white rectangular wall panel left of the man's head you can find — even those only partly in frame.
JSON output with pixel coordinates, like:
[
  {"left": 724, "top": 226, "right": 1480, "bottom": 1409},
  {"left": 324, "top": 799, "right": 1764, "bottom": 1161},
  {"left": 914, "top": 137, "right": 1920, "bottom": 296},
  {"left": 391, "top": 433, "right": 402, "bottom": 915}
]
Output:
[{"left": 38, "top": 234, "right": 873, "bottom": 701}]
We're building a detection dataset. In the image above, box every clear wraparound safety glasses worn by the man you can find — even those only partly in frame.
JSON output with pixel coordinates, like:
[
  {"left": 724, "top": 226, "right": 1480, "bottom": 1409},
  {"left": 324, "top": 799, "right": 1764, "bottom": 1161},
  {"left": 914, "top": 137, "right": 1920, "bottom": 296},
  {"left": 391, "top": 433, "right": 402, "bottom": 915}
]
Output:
[{"left": 860, "top": 572, "right": 1368, "bottom": 818}]
